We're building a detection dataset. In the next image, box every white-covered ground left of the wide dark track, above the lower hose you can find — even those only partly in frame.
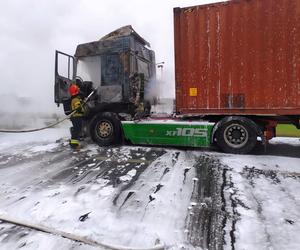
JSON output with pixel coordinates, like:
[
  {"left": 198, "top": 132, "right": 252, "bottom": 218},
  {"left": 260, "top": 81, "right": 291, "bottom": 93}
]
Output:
[{"left": 0, "top": 129, "right": 194, "bottom": 249}]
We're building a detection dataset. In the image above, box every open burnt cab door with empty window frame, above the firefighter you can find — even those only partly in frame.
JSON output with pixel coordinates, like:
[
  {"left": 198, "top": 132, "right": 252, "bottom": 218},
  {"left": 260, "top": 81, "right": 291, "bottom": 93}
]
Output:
[{"left": 54, "top": 51, "right": 76, "bottom": 105}]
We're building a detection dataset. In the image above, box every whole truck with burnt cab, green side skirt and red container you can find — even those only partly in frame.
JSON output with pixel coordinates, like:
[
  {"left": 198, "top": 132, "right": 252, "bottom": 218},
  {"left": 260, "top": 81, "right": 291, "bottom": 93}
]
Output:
[{"left": 55, "top": 0, "right": 300, "bottom": 154}]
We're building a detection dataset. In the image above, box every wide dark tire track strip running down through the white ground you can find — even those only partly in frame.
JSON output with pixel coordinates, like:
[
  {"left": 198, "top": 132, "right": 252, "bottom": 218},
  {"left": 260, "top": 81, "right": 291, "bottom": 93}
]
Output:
[{"left": 186, "top": 154, "right": 228, "bottom": 250}]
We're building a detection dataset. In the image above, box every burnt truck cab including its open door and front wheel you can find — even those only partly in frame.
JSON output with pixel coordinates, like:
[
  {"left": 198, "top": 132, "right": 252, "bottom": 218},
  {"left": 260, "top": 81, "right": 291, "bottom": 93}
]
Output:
[{"left": 54, "top": 26, "right": 155, "bottom": 145}]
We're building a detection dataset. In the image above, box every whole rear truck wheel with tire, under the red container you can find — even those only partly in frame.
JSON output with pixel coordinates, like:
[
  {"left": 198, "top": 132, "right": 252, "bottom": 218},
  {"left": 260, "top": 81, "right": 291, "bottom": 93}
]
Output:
[{"left": 216, "top": 119, "right": 257, "bottom": 154}]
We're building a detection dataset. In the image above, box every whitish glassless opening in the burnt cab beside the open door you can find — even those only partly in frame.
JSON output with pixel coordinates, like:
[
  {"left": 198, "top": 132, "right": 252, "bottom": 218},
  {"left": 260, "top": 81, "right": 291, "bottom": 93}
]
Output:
[{"left": 77, "top": 56, "right": 101, "bottom": 87}]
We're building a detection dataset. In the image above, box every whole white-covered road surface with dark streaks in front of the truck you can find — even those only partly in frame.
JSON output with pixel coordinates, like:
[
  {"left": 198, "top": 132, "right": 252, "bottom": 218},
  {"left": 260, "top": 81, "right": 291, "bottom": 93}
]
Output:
[{"left": 0, "top": 128, "right": 300, "bottom": 249}]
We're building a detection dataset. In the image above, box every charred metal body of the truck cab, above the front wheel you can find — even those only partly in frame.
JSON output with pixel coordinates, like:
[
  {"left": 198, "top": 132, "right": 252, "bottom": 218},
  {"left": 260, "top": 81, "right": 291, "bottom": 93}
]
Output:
[{"left": 55, "top": 26, "right": 155, "bottom": 117}]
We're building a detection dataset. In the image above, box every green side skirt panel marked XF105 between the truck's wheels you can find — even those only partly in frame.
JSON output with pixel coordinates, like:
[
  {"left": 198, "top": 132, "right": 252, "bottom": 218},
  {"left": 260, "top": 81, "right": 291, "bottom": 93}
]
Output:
[{"left": 122, "top": 120, "right": 214, "bottom": 147}]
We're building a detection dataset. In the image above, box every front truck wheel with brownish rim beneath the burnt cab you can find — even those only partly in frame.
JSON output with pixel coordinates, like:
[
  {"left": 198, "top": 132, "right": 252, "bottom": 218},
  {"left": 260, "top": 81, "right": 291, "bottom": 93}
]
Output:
[{"left": 90, "top": 112, "right": 121, "bottom": 146}]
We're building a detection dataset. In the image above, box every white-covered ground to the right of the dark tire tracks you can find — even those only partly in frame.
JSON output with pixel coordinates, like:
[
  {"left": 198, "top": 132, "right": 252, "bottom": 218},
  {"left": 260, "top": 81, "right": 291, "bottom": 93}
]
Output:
[{"left": 214, "top": 149, "right": 300, "bottom": 250}]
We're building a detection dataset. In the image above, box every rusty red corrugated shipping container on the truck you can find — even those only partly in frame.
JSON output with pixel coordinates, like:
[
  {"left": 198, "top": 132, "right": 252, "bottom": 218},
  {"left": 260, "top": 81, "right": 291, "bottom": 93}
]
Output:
[{"left": 174, "top": 0, "right": 300, "bottom": 115}]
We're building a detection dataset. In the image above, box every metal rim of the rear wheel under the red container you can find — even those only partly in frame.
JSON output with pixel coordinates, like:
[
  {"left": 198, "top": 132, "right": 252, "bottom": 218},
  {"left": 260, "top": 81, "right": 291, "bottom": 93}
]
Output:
[{"left": 224, "top": 123, "right": 249, "bottom": 148}]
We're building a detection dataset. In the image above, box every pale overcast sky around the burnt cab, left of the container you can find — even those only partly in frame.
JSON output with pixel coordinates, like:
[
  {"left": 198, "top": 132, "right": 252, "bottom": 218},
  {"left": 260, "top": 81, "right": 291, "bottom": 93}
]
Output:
[{"left": 0, "top": 0, "right": 217, "bottom": 113}]
